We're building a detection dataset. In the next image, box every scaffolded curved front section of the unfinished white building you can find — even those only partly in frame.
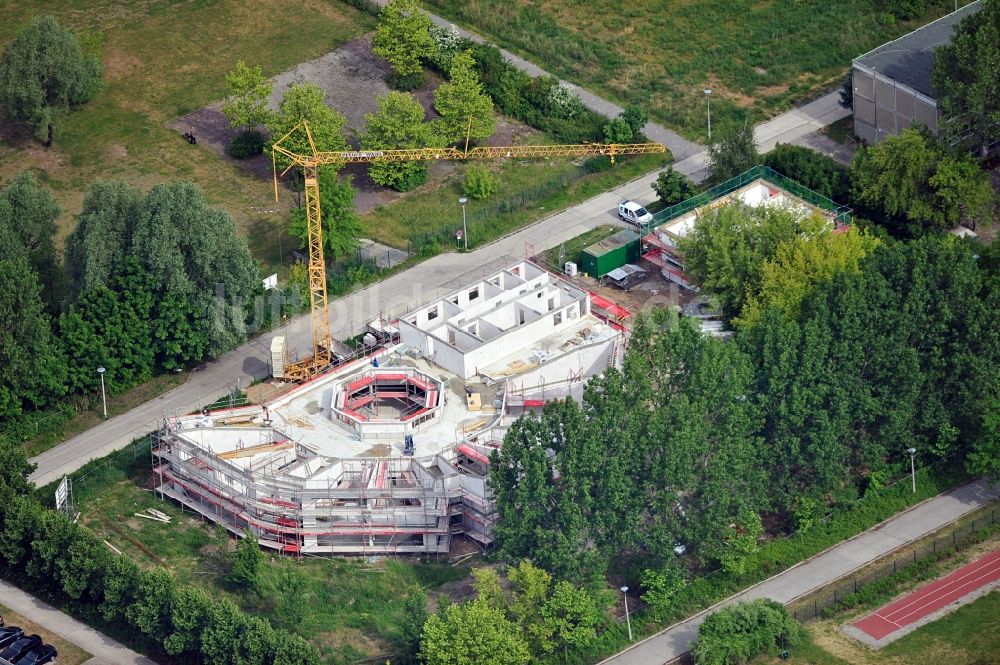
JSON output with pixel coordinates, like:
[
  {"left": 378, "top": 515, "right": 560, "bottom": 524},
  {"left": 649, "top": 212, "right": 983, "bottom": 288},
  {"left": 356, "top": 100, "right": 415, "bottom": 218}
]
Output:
[{"left": 152, "top": 408, "right": 496, "bottom": 556}]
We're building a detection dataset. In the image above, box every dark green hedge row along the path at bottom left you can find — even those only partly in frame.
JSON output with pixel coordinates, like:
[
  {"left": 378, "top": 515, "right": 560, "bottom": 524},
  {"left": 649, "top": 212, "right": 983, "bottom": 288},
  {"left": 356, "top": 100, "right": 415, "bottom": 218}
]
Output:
[{"left": 0, "top": 487, "right": 320, "bottom": 665}]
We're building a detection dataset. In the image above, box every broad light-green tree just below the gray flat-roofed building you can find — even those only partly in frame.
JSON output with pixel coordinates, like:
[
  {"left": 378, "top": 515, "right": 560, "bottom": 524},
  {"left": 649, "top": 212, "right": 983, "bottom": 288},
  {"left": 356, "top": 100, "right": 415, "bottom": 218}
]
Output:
[{"left": 851, "top": 129, "right": 994, "bottom": 233}]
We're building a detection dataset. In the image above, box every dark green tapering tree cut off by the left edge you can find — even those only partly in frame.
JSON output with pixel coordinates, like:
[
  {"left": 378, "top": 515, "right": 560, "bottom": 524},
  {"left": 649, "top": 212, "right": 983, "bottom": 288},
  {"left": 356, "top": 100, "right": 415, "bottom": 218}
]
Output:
[{"left": 0, "top": 256, "right": 66, "bottom": 422}]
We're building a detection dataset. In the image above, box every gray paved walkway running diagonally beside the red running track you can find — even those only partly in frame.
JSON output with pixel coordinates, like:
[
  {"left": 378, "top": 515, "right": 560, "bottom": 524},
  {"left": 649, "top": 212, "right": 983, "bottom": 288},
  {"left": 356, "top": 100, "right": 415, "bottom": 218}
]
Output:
[{"left": 601, "top": 480, "right": 1000, "bottom": 665}]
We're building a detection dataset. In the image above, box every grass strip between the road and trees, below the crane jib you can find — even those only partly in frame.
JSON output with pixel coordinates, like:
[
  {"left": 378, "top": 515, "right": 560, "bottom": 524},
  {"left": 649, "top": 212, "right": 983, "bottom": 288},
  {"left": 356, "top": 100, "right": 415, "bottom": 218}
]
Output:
[{"left": 361, "top": 141, "right": 672, "bottom": 249}]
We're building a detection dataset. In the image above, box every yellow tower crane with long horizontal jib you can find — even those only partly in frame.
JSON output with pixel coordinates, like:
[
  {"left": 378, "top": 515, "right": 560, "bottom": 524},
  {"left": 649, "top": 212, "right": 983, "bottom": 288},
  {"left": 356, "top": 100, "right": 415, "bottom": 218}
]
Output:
[{"left": 271, "top": 120, "right": 666, "bottom": 380}]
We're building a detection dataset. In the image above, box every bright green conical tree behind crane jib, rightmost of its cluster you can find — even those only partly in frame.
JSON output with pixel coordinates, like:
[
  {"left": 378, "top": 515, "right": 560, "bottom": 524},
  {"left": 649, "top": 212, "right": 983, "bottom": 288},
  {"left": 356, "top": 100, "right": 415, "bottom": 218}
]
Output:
[{"left": 361, "top": 92, "right": 435, "bottom": 192}]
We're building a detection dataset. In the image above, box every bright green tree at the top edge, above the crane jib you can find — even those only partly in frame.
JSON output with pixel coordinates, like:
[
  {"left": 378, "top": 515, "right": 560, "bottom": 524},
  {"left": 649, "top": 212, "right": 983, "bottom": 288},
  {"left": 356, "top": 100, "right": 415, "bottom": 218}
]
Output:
[{"left": 372, "top": 0, "right": 436, "bottom": 80}]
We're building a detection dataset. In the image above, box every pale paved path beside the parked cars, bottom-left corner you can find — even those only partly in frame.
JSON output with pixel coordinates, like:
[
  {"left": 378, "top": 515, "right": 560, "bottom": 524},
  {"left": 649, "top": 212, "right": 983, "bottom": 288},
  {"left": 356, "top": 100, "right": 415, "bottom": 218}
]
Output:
[{"left": 0, "top": 580, "right": 156, "bottom": 665}]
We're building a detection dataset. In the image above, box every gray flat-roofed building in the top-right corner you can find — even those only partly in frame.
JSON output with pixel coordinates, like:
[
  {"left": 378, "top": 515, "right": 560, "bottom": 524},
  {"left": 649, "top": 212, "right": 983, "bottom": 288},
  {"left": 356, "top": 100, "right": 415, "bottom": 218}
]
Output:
[{"left": 851, "top": 0, "right": 982, "bottom": 144}]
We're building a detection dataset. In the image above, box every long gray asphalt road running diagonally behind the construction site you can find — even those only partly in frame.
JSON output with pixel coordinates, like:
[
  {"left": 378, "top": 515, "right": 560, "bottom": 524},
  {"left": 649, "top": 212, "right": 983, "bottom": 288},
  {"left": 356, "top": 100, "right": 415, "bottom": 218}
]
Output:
[{"left": 31, "top": 92, "right": 848, "bottom": 486}]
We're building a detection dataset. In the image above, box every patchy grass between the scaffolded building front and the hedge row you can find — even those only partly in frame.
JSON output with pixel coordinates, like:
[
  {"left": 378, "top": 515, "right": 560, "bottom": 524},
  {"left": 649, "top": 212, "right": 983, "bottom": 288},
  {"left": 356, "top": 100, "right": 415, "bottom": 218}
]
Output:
[{"left": 73, "top": 453, "right": 468, "bottom": 665}]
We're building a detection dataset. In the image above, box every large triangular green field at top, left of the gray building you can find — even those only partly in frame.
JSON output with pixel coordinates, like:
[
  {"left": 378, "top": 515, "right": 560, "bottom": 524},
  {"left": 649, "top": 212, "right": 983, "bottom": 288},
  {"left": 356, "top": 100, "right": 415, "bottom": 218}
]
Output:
[{"left": 425, "top": 0, "right": 968, "bottom": 139}]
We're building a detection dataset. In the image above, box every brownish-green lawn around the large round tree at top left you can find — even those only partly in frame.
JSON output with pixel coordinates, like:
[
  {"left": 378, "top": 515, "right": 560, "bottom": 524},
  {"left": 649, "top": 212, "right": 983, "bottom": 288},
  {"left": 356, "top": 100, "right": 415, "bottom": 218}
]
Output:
[{"left": 0, "top": 0, "right": 374, "bottom": 272}]
